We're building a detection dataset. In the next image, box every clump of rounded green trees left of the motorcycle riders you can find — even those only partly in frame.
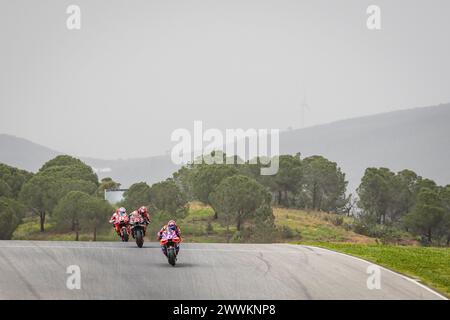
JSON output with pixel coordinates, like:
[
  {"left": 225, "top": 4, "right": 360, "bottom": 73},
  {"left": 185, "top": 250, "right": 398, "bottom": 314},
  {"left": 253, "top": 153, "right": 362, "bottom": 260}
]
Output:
[{"left": 0, "top": 155, "right": 113, "bottom": 240}]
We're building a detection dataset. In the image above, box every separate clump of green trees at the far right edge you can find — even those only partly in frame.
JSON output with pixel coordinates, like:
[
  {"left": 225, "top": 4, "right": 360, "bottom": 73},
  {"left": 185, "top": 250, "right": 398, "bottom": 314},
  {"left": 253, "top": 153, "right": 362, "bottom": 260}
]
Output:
[{"left": 357, "top": 168, "right": 450, "bottom": 245}]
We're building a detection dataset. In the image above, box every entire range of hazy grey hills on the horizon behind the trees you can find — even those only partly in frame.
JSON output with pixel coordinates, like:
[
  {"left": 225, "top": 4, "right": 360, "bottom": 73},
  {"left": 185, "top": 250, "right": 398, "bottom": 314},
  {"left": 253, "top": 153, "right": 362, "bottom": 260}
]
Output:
[{"left": 0, "top": 104, "right": 450, "bottom": 190}]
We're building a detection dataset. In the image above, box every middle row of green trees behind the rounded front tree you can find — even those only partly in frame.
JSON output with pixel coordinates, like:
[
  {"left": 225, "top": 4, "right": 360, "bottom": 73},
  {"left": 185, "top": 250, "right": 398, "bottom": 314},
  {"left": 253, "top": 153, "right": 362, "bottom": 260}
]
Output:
[{"left": 173, "top": 154, "right": 347, "bottom": 213}]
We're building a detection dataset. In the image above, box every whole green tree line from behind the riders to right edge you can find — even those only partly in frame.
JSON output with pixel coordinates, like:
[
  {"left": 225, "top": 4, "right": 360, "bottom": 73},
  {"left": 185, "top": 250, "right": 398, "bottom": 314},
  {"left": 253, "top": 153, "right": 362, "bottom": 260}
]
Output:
[{"left": 122, "top": 152, "right": 450, "bottom": 245}]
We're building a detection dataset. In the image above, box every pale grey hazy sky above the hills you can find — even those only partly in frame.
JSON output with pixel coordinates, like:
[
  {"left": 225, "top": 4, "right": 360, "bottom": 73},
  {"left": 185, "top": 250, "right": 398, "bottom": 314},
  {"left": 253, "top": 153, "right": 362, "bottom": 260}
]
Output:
[{"left": 0, "top": 0, "right": 450, "bottom": 158}]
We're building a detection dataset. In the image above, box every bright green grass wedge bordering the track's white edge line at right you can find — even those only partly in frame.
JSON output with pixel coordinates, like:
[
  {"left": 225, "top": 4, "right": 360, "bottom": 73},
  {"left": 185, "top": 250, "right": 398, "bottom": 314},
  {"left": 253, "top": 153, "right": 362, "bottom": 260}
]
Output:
[{"left": 302, "top": 242, "right": 450, "bottom": 297}]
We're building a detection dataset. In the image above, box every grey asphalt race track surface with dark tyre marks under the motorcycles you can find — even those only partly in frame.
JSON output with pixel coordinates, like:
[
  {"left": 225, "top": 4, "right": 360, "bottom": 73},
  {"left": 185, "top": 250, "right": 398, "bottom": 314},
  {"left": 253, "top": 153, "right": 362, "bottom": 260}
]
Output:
[{"left": 0, "top": 241, "right": 443, "bottom": 300}]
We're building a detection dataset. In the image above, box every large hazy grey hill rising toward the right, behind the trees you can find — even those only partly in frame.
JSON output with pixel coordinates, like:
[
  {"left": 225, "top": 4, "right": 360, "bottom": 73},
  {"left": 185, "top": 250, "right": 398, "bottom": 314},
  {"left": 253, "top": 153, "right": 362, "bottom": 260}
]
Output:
[{"left": 280, "top": 104, "right": 450, "bottom": 190}]
